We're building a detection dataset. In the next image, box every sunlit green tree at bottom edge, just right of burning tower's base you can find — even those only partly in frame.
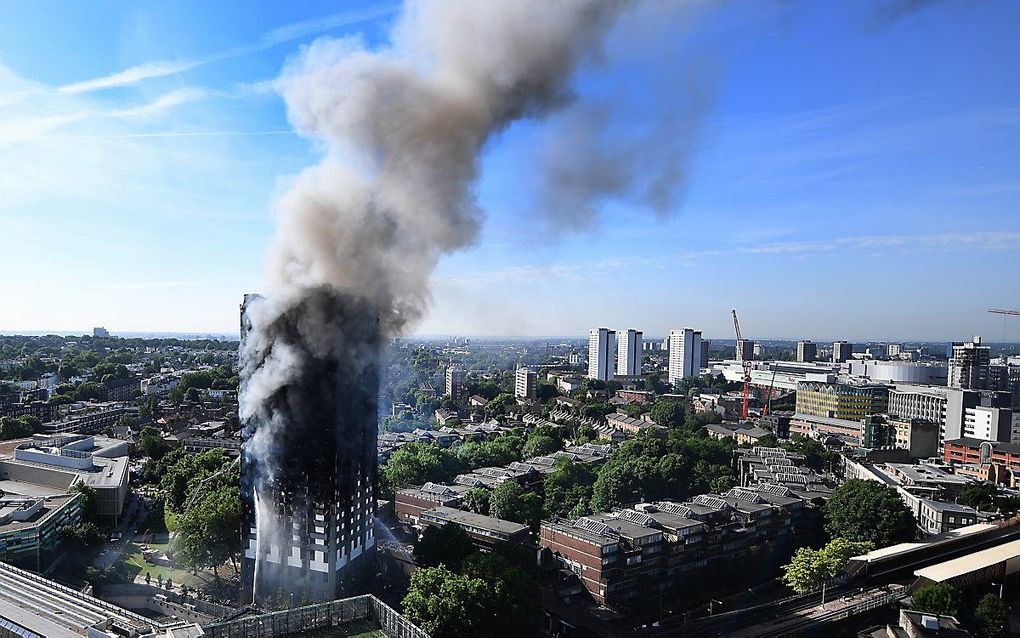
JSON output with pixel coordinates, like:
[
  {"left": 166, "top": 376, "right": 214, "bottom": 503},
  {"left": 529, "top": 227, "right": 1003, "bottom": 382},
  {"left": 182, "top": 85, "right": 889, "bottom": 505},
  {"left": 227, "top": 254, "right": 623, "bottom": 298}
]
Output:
[{"left": 404, "top": 565, "right": 493, "bottom": 638}]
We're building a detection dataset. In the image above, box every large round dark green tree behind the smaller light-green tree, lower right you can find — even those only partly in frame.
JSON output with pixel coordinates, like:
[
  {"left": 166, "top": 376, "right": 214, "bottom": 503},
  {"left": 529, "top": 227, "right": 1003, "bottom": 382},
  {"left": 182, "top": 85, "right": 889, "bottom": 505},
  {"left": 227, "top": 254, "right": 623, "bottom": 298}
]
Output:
[{"left": 824, "top": 479, "right": 917, "bottom": 547}]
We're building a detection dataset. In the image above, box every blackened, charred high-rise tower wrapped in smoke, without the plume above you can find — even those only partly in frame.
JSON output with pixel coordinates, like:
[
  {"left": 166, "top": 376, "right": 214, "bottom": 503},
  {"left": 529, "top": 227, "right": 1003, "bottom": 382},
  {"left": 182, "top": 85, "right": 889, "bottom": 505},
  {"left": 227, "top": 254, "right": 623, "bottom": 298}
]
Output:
[{"left": 241, "top": 288, "right": 379, "bottom": 603}]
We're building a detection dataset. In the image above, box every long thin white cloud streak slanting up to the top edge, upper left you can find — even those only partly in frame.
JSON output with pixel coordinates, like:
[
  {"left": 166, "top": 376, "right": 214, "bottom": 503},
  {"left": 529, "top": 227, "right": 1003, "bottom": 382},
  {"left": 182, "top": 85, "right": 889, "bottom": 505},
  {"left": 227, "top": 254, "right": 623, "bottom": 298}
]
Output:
[{"left": 59, "top": 4, "right": 397, "bottom": 94}]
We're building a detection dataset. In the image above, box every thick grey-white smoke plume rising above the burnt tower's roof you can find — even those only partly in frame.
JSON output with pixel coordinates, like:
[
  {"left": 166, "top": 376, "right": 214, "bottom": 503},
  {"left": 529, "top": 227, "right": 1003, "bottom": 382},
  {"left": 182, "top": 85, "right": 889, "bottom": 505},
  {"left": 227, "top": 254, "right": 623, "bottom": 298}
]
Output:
[{"left": 259, "top": 0, "right": 627, "bottom": 334}]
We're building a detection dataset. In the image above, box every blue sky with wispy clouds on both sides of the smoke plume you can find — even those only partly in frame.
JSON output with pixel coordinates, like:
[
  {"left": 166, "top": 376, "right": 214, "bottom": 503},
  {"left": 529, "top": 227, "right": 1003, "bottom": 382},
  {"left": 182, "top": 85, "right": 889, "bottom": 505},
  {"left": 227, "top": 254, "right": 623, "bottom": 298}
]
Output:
[{"left": 0, "top": 0, "right": 1020, "bottom": 341}]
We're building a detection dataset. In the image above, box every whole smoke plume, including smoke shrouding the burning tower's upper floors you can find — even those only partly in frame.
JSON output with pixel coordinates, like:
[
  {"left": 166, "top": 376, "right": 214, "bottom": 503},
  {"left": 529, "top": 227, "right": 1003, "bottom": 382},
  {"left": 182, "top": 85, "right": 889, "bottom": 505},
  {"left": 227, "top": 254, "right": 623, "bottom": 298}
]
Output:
[{"left": 241, "top": 0, "right": 652, "bottom": 596}]
